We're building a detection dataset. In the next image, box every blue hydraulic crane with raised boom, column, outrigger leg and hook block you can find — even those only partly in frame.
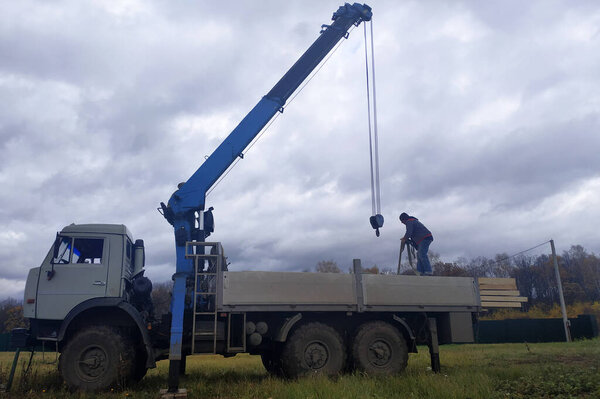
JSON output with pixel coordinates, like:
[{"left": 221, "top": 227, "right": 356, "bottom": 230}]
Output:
[{"left": 161, "top": 3, "right": 376, "bottom": 392}]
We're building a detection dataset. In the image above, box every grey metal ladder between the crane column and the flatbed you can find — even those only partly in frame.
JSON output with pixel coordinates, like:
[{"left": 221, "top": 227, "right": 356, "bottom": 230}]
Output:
[{"left": 185, "top": 242, "right": 225, "bottom": 354}]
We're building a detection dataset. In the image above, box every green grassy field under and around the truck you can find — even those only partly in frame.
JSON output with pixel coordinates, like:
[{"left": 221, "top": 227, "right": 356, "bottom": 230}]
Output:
[{"left": 0, "top": 339, "right": 600, "bottom": 399}]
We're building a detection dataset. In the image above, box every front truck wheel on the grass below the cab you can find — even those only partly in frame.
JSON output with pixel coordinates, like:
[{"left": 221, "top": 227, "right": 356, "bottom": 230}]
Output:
[{"left": 59, "top": 326, "right": 134, "bottom": 391}]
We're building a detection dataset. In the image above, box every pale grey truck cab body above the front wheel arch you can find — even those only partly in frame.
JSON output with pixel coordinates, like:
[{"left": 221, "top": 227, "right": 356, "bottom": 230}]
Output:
[{"left": 23, "top": 224, "right": 144, "bottom": 320}]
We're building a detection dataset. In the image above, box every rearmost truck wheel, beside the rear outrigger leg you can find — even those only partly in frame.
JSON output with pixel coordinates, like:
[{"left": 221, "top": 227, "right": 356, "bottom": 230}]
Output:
[{"left": 352, "top": 321, "right": 408, "bottom": 375}]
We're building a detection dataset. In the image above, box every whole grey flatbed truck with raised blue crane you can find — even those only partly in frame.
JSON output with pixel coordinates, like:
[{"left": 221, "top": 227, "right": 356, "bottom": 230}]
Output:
[{"left": 13, "top": 3, "right": 481, "bottom": 392}]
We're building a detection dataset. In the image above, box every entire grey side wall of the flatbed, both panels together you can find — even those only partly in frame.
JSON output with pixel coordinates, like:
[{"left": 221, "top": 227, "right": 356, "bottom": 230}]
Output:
[{"left": 217, "top": 271, "right": 481, "bottom": 312}]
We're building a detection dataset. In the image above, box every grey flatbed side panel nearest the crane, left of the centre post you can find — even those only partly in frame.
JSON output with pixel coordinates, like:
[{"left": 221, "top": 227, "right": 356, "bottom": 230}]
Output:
[{"left": 223, "top": 272, "right": 356, "bottom": 307}]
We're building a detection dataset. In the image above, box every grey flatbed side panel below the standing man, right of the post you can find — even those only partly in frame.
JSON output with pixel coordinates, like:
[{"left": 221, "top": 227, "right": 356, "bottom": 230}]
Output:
[{"left": 362, "top": 274, "right": 480, "bottom": 307}]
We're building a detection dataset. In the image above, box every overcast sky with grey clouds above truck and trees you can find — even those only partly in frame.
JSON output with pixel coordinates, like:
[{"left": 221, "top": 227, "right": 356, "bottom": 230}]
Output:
[{"left": 0, "top": 0, "right": 600, "bottom": 298}]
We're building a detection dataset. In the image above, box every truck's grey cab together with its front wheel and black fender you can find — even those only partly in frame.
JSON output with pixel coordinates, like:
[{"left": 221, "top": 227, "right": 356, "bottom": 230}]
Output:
[{"left": 23, "top": 224, "right": 157, "bottom": 390}]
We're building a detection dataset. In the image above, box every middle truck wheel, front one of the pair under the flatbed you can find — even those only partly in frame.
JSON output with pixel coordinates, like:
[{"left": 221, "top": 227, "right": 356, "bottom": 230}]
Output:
[{"left": 281, "top": 322, "right": 346, "bottom": 378}]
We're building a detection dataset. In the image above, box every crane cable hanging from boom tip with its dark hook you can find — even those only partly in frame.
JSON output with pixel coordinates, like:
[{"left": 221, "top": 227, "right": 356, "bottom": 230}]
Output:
[{"left": 364, "top": 19, "right": 383, "bottom": 237}]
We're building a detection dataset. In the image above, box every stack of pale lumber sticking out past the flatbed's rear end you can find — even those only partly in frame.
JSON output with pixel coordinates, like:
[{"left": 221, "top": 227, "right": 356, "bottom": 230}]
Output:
[{"left": 477, "top": 277, "right": 527, "bottom": 308}]
